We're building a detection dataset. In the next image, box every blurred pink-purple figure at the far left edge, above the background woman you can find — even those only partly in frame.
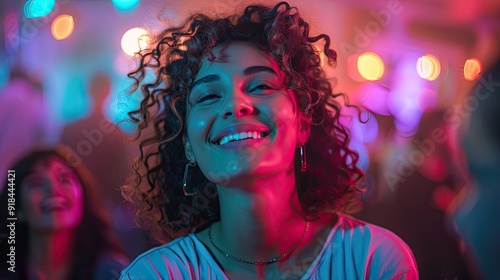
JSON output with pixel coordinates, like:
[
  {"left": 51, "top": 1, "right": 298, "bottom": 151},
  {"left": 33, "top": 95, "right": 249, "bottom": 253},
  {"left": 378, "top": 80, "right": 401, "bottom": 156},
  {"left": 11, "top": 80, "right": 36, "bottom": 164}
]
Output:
[{"left": 0, "top": 69, "right": 59, "bottom": 194}]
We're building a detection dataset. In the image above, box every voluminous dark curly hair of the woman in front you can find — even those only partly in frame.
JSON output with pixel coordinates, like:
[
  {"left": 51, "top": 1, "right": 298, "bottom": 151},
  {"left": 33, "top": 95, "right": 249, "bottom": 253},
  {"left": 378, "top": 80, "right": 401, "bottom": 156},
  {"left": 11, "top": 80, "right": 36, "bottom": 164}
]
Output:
[{"left": 122, "top": 2, "right": 363, "bottom": 242}]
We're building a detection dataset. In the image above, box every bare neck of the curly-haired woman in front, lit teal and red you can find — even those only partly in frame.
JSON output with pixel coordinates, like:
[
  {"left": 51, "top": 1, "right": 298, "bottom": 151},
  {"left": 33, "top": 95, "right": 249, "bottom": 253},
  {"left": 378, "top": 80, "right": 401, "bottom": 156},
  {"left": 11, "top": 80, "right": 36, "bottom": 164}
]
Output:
[{"left": 215, "top": 172, "right": 306, "bottom": 261}]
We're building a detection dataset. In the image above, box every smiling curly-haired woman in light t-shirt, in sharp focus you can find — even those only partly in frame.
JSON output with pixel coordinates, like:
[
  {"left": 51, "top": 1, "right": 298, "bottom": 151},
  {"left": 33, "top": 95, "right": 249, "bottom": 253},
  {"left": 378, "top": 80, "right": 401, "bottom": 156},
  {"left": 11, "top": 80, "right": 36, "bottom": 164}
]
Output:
[{"left": 122, "top": 2, "right": 418, "bottom": 279}]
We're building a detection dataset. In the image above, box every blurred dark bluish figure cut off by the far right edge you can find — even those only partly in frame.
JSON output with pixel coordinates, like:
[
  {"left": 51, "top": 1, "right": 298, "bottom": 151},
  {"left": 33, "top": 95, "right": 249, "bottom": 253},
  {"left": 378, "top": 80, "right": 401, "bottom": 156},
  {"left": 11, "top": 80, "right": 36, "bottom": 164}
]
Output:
[{"left": 452, "top": 55, "right": 500, "bottom": 279}]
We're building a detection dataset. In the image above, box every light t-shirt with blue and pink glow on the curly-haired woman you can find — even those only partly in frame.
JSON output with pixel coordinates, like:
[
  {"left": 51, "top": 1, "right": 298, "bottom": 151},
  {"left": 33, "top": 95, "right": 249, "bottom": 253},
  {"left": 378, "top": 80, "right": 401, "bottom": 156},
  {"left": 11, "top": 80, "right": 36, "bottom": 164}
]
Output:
[{"left": 120, "top": 215, "right": 418, "bottom": 280}]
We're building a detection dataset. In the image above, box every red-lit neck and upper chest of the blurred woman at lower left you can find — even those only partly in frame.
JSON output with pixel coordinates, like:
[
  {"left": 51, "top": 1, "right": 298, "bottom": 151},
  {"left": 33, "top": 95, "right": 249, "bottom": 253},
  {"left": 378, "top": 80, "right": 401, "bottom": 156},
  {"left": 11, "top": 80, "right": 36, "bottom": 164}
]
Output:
[{"left": 29, "top": 230, "right": 74, "bottom": 279}]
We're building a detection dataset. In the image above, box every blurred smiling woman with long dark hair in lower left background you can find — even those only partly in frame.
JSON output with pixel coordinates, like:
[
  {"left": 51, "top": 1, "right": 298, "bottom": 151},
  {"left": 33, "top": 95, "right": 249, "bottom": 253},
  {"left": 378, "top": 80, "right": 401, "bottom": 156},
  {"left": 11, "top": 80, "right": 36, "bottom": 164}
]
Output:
[{"left": 0, "top": 147, "right": 128, "bottom": 280}]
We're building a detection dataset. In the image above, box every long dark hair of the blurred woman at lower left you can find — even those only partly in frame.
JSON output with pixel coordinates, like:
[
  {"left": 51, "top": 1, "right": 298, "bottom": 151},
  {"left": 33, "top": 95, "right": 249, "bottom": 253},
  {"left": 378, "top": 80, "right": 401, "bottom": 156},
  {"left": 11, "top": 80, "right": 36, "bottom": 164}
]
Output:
[{"left": 0, "top": 146, "right": 126, "bottom": 279}]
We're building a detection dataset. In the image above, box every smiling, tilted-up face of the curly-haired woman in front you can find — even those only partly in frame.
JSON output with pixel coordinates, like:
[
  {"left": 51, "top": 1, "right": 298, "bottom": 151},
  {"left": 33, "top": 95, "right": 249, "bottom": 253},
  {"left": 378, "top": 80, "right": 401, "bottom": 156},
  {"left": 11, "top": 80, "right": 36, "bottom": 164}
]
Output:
[{"left": 184, "top": 43, "right": 310, "bottom": 186}]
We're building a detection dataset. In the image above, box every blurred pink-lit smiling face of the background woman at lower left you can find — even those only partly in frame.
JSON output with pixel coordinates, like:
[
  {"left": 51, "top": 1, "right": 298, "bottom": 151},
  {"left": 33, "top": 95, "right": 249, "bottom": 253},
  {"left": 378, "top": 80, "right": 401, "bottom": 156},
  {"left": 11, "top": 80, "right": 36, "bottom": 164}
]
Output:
[{"left": 21, "top": 157, "right": 83, "bottom": 232}]
